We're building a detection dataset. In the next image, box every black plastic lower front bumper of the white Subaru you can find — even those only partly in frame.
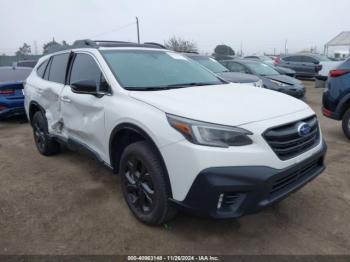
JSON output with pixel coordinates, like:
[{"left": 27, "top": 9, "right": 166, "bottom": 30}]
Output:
[{"left": 172, "top": 142, "right": 327, "bottom": 218}]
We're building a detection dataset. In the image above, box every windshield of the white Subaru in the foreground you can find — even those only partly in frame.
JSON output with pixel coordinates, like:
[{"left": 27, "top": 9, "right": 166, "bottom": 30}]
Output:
[{"left": 102, "top": 50, "right": 224, "bottom": 91}]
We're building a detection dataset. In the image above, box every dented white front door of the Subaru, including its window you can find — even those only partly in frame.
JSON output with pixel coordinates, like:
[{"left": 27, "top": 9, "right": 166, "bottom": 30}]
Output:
[{"left": 61, "top": 52, "right": 110, "bottom": 158}]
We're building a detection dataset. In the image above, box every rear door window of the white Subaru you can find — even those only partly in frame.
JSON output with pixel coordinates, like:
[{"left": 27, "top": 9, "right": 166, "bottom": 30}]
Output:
[{"left": 49, "top": 53, "right": 69, "bottom": 84}]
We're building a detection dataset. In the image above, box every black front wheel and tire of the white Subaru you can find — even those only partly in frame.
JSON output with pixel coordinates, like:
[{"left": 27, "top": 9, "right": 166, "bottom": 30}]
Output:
[{"left": 119, "top": 141, "right": 176, "bottom": 225}]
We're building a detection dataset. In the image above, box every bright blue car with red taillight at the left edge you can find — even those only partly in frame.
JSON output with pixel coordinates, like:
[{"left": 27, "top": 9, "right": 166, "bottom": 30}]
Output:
[{"left": 0, "top": 66, "right": 32, "bottom": 119}]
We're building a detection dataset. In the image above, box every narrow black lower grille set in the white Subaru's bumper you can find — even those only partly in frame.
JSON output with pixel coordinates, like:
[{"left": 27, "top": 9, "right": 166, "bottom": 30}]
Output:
[{"left": 270, "top": 158, "right": 323, "bottom": 196}]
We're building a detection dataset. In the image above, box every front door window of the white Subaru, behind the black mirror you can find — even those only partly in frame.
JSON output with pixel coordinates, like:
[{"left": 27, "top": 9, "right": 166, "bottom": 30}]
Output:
[{"left": 69, "top": 54, "right": 109, "bottom": 92}]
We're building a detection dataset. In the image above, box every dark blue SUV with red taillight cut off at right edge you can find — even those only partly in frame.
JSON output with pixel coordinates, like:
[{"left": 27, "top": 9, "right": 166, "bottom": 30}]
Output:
[{"left": 322, "top": 58, "right": 350, "bottom": 139}]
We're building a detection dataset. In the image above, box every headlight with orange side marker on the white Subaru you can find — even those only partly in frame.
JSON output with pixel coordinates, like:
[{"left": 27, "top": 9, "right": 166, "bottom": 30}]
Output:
[{"left": 167, "top": 114, "right": 253, "bottom": 147}]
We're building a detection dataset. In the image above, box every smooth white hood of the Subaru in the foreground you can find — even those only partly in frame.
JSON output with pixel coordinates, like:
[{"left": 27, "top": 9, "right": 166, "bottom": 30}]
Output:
[{"left": 129, "top": 84, "right": 309, "bottom": 126}]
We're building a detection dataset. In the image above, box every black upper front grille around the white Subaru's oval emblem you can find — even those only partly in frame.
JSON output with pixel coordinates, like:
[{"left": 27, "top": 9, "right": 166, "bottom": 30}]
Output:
[{"left": 263, "top": 116, "right": 320, "bottom": 160}]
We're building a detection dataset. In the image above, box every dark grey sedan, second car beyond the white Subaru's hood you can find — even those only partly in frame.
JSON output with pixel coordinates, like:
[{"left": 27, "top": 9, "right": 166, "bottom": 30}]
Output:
[{"left": 219, "top": 59, "right": 305, "bottom": 98}]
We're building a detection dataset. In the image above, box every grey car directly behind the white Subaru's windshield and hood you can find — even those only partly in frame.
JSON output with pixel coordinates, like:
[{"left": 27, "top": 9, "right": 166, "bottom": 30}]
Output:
[{"left": 184, "top": 53, "right": 263, "bottom": 87}]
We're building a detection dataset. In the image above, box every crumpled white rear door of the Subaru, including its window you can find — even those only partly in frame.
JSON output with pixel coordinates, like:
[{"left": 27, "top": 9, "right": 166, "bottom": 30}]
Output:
[{"left": 36, "top": 53, "right": 70, "bottom": 134}]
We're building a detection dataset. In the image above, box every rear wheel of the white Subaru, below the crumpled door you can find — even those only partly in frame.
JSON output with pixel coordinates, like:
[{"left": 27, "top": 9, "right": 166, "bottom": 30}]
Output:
[{"left": 32, "top": 111, "right": 60, "bottom": 156}]
